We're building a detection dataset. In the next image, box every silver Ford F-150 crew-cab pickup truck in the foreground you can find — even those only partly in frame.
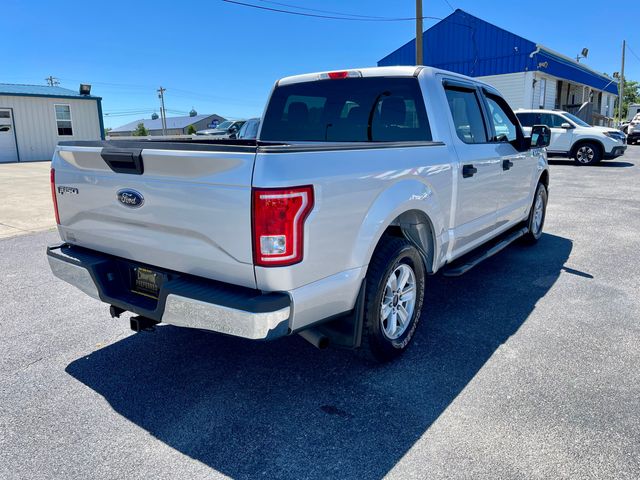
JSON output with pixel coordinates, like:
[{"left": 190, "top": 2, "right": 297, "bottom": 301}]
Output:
[{"left": 47, "top": 67, "right": 550, "bottom": 361}]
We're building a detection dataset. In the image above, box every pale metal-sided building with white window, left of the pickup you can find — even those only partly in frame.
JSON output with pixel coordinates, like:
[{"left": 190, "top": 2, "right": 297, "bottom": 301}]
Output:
[{"left": 0, "top": 83, "right": 104, "bottom": 163}]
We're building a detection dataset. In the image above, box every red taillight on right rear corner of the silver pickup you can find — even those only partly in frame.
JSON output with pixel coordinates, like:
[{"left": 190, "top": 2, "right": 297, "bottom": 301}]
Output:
[{"left": 253, "top": 185, "right": 313, "bottom": 267}]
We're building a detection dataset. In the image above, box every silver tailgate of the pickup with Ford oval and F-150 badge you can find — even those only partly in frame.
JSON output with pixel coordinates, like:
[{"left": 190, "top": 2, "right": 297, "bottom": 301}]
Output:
[{"left": 52, "top": 145, "right": 256, "bottom": 288}]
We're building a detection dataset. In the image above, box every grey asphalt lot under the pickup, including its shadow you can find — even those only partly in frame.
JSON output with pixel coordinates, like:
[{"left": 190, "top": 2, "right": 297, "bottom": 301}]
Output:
[{"left": 0, "top": 146, "right": 640, "bottom": 479}]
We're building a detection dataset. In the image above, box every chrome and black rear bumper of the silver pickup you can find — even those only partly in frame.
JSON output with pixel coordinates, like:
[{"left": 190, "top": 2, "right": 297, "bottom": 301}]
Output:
[{"left": 47, "top": 244, "right": 292, "bottom": 340}]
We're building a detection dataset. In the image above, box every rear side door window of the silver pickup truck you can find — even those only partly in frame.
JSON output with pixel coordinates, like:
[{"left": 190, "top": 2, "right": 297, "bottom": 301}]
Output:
[{"left": 445, "top": 86, "right": 487, "bottom": 143}]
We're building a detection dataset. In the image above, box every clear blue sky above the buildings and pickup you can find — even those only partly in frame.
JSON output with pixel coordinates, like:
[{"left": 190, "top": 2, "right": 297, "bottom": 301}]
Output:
[{"left": 0, "top": 0, "right": 640, "bottom": 127}]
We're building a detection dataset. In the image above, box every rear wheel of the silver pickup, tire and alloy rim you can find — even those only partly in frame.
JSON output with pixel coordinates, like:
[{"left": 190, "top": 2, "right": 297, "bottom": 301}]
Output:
[{"left": 360, "top": 237, "right": 425, "bottom": 362}]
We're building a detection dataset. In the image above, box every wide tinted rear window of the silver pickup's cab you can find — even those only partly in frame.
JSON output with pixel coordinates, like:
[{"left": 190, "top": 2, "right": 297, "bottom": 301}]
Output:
[{"left": 260, "top": 77, "right": 432, "bottom": 142}]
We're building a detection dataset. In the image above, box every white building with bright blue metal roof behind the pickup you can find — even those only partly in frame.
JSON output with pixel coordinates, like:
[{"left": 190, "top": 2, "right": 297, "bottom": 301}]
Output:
[{"left": 378, "top": 9, "right": 618, "bottom": 125}]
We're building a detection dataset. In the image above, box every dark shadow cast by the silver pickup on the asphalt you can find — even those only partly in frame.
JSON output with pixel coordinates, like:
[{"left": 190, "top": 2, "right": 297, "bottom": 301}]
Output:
[{"left": 66, "top": 235, "right": 572, "bottom": 479}]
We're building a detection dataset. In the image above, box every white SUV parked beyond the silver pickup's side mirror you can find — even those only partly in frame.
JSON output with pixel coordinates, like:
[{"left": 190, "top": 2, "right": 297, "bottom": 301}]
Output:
[{"left": 516, "top": 109, "right": 627, "bottom": 165}]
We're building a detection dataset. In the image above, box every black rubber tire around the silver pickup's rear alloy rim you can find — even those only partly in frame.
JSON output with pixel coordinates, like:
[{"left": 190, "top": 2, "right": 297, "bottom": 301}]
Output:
[{"left": 358, "top": 236, "right": 426, "bottom": 363}]
